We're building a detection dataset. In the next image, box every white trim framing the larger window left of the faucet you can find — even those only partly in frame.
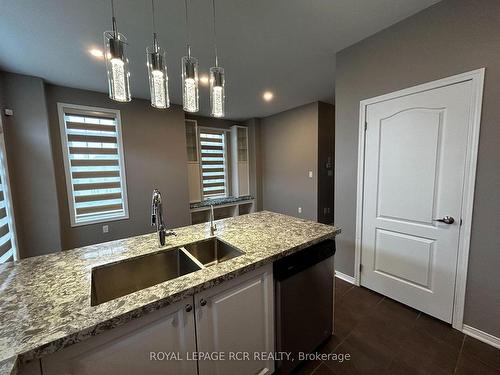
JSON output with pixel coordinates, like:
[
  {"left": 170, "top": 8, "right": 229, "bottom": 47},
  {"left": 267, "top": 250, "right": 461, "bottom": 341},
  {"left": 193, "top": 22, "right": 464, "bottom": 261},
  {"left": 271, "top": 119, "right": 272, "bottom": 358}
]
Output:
[{"left": 57, "top": 103, "right": 130, "bottom": 227}]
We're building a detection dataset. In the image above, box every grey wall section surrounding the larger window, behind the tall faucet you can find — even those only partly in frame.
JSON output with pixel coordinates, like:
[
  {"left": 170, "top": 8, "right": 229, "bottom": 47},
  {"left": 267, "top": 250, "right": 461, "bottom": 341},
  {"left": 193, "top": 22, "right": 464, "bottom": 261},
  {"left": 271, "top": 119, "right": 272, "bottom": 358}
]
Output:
[{"left": 45, "top": 85, "right": 190, "bottom": 249}]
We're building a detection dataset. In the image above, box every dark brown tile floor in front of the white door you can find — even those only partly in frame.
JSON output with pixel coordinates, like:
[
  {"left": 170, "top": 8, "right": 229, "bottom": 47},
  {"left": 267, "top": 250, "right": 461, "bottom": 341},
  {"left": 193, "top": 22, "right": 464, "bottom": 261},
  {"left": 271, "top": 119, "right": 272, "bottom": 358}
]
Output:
[{"left": 296, "top": 278, "right": 500, "bottom": 375}]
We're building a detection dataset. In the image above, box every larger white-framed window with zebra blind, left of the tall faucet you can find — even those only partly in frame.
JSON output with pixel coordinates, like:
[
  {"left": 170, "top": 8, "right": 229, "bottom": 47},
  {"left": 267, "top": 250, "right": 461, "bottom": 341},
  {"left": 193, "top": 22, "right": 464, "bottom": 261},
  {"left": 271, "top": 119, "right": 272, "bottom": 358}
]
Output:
[{"left": 58, "top": 103, "right": 128, "bottom": 226}]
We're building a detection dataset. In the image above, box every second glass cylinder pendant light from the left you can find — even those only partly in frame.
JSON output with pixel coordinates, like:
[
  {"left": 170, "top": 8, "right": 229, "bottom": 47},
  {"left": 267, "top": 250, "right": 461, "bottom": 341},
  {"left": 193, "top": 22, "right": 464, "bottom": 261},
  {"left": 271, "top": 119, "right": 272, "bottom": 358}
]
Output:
[{"left": 146, "top": 0, "right": 170, "bottom": 108}]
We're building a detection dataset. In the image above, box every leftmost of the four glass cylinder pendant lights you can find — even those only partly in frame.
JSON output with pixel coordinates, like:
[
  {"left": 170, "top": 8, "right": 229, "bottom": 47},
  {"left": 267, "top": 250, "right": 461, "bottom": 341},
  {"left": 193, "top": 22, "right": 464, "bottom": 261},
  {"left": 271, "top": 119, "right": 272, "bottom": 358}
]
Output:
[{"left": 104, "top": 0, "right": 131, "bottom": 102}]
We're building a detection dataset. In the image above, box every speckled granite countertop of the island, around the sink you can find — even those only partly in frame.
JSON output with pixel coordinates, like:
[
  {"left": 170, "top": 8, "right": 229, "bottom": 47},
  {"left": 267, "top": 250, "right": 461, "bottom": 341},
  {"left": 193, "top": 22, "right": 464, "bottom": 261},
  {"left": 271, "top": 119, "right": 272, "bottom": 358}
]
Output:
[{"left": 0, "top": 211, "right": 340, "bottom": 375}]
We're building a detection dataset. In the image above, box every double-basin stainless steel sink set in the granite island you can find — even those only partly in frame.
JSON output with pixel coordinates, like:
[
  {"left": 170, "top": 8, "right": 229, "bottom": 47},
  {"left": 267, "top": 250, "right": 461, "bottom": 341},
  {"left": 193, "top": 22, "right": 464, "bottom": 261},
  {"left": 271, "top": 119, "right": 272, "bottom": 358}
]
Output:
[{"left": 91, "top": 237, "right": 243, "bottom": 306}]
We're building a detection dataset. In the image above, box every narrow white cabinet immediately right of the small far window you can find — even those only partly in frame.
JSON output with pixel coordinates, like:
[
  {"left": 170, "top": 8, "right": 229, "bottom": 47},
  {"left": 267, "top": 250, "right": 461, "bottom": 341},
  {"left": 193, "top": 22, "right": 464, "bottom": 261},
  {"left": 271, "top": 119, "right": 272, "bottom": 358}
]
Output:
[{"left": 231, "top": 125, "right": 250, "bottom": 197}]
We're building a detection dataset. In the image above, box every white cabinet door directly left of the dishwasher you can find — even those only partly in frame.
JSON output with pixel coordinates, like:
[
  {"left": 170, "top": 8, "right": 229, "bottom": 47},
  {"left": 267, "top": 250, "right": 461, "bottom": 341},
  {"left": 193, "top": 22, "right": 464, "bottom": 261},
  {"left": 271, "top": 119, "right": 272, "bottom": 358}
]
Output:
[{"left": 195, "top": 265, "right": 274, "bottom": 375}]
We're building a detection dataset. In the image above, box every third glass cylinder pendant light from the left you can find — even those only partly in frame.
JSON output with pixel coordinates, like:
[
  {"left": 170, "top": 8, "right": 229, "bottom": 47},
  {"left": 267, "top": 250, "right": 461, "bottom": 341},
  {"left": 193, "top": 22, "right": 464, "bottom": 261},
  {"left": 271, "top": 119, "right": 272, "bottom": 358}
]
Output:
[{"left": 181, "top": 0, "right": 199, "bottom": 112}]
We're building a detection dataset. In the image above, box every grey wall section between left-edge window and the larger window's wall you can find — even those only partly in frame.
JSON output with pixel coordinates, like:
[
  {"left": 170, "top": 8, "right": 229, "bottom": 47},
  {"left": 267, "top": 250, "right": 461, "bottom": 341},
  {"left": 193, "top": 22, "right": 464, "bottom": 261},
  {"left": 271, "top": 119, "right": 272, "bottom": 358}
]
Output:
[{"left": 0, "top": 73, "right": 61, "bottom": 257}]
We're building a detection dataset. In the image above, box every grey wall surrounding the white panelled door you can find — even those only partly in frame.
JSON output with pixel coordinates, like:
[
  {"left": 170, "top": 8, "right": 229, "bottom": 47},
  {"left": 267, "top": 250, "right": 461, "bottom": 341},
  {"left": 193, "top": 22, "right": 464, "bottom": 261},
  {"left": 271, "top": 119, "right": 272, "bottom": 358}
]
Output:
[{"left": 335, "top": 0, "right": 500, "bottom": 337}]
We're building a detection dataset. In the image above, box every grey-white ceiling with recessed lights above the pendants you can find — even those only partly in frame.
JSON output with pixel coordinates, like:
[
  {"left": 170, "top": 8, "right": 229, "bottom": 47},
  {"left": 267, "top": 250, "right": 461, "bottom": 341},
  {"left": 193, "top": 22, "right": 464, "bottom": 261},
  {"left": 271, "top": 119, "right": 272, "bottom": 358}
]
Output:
[{"left": 0, "top": 0, "right": 439, "bottom": 119}]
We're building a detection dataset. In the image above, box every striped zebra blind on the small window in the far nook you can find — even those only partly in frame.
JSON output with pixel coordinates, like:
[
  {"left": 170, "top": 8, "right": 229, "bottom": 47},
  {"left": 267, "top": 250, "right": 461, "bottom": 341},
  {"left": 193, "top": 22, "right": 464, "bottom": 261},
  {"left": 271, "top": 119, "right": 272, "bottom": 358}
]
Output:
[{"left": 200, "top": 128, "right": 227, "bottom": 199}]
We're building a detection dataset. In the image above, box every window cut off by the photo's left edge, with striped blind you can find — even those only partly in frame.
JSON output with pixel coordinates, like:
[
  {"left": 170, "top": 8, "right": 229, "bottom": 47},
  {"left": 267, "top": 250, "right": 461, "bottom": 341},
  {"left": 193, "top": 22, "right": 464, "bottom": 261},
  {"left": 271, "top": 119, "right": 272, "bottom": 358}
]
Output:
[{"left": 0, "top": 131, "right": 18, "bottom": 263}]
